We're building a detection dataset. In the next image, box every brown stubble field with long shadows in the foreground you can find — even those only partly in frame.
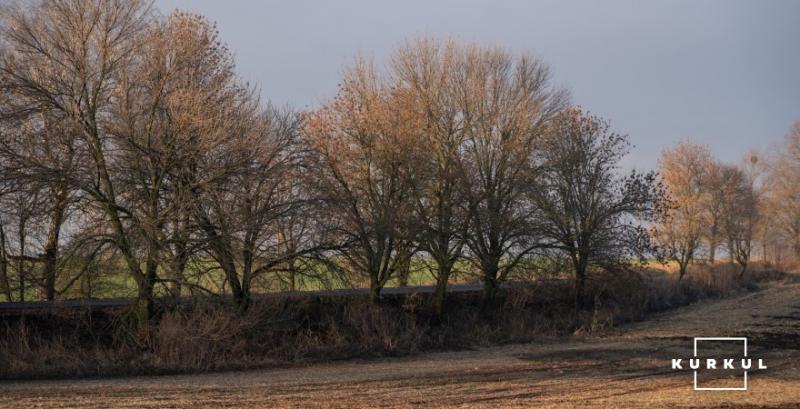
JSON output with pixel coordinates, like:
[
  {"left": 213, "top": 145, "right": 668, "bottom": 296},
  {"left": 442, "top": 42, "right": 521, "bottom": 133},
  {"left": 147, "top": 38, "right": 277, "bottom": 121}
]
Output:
[{"left": 0, "top": 284, "right": 800, "bottom": 408}]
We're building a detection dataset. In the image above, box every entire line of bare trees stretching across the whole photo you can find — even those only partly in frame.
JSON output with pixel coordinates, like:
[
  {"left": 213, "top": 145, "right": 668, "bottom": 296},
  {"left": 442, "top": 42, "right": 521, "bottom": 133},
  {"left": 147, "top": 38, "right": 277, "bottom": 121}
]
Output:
[{"left": 0, "top": 0, "right": 800, "bottom": 330}]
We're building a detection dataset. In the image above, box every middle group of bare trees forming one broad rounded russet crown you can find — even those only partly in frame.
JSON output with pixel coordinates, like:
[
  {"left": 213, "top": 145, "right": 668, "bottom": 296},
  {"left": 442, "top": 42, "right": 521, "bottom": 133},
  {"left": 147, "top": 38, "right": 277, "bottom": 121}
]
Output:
[{"left": 301, "top": 39, "right": 663, "bottom": 311}]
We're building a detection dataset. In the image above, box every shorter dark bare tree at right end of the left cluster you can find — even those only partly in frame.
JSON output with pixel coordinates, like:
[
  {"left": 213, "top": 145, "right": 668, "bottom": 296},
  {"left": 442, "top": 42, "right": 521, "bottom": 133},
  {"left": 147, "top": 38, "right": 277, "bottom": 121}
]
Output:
[{"left": 195, "top": 108, "right": 318, "bottom": 311}]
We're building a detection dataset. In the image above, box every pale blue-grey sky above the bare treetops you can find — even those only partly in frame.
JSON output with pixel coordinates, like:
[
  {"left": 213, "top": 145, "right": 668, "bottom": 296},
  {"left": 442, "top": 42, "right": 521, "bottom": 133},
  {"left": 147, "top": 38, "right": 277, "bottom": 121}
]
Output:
[{"left": 156, "top": 0, "right": 800, "bottom": 168}]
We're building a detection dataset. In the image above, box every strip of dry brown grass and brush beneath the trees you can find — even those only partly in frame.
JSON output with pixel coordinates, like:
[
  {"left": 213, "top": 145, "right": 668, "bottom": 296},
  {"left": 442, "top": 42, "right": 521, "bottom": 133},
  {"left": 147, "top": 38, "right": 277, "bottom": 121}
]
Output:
[{"left": 0, "top": 266, "right": 788, "bottom": 379}]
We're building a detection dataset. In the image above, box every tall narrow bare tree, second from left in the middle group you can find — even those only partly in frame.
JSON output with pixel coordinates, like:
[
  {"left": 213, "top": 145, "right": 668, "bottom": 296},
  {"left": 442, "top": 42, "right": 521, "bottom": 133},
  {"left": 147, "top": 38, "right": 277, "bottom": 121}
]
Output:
[{"left": 392, "top": 39, "right": 469, "bottom": 314}]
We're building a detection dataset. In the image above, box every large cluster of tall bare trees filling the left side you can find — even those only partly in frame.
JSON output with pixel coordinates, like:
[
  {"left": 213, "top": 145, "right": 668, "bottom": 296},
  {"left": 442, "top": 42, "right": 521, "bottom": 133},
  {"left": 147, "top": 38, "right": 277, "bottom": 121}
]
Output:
[{"left": 0, "top": 0, "right": 295, "bottom": 328}]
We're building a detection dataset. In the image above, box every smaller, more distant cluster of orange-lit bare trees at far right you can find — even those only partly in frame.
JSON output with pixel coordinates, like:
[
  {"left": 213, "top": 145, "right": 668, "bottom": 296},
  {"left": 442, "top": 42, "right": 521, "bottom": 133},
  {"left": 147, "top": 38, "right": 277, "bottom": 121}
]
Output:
[{"left": 652, "top": 122, "right": 800, "bottom": 278}]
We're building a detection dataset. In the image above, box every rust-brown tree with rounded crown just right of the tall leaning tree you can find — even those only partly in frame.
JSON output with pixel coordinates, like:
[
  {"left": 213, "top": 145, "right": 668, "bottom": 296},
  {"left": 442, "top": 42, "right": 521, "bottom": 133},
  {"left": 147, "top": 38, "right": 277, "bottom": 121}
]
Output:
[{"left": 108, "top": 12, "right": 258, "bottom": 310}]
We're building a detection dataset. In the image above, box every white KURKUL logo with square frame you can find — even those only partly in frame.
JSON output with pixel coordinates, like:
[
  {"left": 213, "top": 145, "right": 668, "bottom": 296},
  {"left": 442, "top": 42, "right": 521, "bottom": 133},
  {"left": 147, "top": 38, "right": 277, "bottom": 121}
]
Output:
[{"left": 672, "top": 337, "right": 767, "bottom": 391}]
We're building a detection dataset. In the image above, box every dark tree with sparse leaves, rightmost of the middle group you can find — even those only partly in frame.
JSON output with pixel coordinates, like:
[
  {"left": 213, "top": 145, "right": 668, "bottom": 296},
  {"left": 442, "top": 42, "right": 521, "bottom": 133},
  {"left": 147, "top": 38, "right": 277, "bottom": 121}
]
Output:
[{"left": 530, "top": 107, "right": 663, "bottom": 310}]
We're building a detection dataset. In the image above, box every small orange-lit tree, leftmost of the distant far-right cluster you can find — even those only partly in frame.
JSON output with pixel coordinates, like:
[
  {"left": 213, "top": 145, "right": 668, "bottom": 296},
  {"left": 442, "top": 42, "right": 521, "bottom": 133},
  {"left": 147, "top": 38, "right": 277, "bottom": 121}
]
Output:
[{"left": 652, "top": 141, "right": 713, "bottom": 280}]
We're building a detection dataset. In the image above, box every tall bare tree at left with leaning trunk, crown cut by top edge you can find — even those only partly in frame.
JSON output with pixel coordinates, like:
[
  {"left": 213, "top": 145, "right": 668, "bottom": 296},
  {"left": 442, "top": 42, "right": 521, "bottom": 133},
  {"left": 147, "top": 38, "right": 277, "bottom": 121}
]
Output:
[{"left": 0, "top": 0, "right": 184, "bottom": 330}]
